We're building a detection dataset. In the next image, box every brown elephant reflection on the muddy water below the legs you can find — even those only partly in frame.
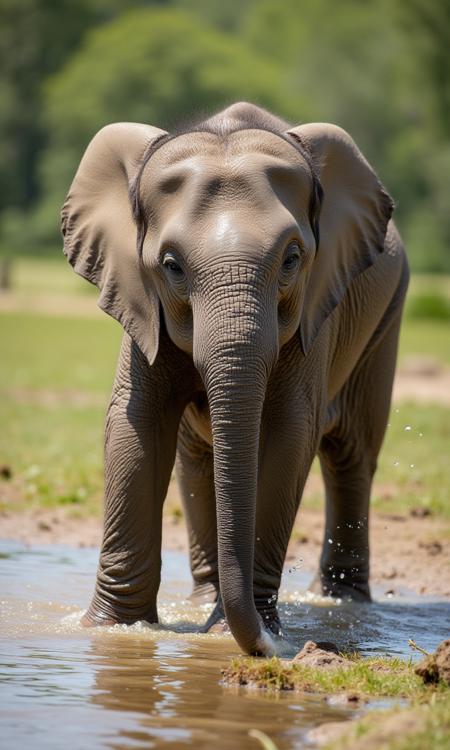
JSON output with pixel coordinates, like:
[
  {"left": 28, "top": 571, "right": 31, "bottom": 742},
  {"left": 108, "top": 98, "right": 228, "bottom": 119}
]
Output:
[{"left": 86, "top": 638, "right": 352, "bottom": 748}]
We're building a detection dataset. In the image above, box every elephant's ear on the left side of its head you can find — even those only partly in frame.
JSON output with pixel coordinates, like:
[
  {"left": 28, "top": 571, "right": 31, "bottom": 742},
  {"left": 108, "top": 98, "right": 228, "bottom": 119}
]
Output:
[{"left": 62, "top": 122, "right": 166, "bottom": 364}]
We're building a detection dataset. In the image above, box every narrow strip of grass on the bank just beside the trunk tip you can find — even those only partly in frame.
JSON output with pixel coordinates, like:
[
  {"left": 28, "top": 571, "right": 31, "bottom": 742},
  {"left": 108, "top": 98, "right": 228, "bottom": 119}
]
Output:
[{"left": 223, "top": 655, "right": 436, "bottom": 698}]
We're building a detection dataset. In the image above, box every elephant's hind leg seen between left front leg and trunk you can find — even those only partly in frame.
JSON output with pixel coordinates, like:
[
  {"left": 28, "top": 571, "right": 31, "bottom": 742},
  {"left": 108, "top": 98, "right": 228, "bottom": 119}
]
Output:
[{"left": 175, "top": 407, "right": 219, "bottom": 603}]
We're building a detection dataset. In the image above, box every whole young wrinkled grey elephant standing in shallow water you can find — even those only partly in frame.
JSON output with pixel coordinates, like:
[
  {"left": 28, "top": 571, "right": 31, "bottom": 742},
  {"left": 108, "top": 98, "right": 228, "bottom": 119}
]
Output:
[{"left": 63, "top": 103, "right": 408, "bottom": 654}]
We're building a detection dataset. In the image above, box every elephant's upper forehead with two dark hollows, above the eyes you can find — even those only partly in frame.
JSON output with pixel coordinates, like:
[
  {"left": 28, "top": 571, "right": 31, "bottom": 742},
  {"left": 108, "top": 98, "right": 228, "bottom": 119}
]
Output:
[{"left": 141, "top": 130, "right": 311, "bottom": 218}]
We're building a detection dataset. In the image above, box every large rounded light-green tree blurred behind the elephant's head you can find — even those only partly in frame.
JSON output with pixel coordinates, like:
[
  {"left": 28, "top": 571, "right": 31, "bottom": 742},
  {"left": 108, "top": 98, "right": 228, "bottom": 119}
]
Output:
[{"left": 33, "top": 9, "right": 282, "bottom": 247}]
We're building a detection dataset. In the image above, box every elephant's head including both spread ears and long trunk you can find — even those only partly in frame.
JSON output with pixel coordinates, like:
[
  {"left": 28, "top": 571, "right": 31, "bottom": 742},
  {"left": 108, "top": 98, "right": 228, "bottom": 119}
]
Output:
[{"left": 63, "top": 104, "right": 392, "bottom": 653}]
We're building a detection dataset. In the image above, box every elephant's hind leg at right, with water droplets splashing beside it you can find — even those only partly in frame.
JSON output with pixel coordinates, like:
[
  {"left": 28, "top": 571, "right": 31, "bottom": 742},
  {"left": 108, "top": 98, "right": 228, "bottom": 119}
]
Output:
[{"left": 315, "top": 314, "right": 400, "bottom": 600}]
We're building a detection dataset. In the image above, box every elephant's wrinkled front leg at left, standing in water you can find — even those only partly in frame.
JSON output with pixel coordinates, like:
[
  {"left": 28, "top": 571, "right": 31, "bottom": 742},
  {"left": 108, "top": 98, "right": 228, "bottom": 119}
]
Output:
[{"left": 84, "top": 342, "right": 185, "bottom": 625}]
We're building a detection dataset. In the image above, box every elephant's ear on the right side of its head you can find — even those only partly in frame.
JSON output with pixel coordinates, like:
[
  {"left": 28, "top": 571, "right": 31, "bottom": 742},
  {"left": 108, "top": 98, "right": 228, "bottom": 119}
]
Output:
[{"left": 288, "top": 123, "right": 393, "bottom": 353}]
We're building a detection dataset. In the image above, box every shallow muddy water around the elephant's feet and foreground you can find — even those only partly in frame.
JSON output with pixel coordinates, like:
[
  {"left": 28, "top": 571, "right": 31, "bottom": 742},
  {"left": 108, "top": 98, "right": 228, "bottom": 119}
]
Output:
[{"left": 0, "top": 542, "right": 450, "bottom": 750}]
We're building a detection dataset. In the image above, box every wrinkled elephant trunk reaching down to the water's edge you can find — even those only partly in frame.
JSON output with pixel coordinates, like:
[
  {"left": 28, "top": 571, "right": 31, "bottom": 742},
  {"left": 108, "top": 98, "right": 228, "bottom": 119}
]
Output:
[{"left": 194, "top": 284, "right": 278, "bottom": 655}]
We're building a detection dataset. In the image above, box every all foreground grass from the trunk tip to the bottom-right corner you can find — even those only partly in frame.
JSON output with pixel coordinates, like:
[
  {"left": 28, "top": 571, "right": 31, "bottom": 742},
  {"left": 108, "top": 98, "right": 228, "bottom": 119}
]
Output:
[{"left": 229, "top": 654, "right": 450, "bottom": 750}]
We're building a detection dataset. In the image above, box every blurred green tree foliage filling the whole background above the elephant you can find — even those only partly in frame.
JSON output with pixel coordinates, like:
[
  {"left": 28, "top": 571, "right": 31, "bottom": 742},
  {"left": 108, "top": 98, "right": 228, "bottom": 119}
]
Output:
[{"left": 0, "top": 0, "right": 450, "bottom": 271}]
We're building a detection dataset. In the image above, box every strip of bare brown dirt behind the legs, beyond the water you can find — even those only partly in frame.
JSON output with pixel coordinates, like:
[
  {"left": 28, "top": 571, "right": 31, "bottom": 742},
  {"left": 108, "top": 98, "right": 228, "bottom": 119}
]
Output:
[{"left": 0, "top": 480, "right": 450, "bottom": 599}]
